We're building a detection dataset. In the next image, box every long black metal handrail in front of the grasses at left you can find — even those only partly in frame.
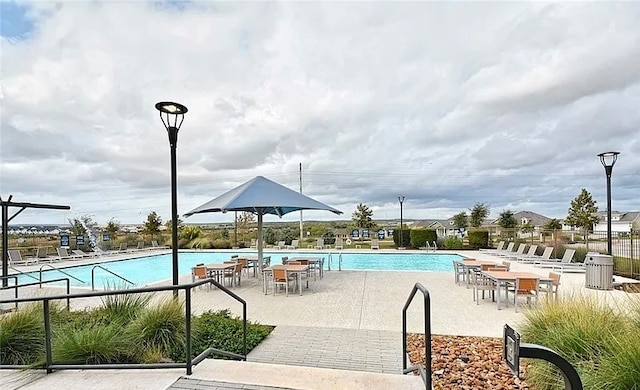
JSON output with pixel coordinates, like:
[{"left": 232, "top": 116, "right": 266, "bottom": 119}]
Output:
[{"left": 0, "top": 279, "right": 247, "bottom": 375}]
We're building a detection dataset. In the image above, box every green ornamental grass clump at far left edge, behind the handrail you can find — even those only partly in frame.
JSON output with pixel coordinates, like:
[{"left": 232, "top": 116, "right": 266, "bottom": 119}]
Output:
[{"left": 0, "top": 305, "right": 44, "bottom": 365}]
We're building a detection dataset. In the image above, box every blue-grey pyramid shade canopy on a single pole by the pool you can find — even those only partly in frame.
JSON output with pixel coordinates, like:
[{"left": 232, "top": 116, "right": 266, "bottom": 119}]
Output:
[{"left": 184, "top": 176, "right": 342, "bottom": 270}]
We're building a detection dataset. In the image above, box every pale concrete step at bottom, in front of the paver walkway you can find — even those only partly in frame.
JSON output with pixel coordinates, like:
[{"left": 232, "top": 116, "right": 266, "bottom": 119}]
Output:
[{"left": 180, "top": 359, "right": 424, "bottom": 390}]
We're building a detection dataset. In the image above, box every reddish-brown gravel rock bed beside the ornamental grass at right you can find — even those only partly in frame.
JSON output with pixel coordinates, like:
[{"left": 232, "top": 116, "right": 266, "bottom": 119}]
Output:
[{"left": 407, "top": 334, "right": 533, "bottom": 390}]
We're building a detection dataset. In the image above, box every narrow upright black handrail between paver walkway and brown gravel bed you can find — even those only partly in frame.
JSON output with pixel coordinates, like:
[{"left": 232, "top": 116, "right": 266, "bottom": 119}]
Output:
[{"left": 402, "top": 283, "right": 431, "bottom": 390}]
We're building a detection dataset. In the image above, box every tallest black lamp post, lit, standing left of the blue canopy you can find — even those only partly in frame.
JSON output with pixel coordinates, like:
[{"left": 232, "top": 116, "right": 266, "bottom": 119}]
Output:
[{"left": 156, "top": 102, "right": 188, "bottom": 296}]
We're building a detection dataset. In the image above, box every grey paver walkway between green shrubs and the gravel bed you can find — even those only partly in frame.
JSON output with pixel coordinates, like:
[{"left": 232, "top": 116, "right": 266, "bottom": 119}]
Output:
[{"left": 247, "top": 325, "right": 402, "bottom": 374}]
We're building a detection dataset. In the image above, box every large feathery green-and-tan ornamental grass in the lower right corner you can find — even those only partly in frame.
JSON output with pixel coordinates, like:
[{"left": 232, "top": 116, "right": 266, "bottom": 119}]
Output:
[{"left": 521, "top": 295, "right": 640, "bottom": 389}]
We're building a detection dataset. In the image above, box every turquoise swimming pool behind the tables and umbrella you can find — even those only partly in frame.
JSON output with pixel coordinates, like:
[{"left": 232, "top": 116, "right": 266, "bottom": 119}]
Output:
[{"left": 18, "top": 251, "right": 460, "bottom": 286}]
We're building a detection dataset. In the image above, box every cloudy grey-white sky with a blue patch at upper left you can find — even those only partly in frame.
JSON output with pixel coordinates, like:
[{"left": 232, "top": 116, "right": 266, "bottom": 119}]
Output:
[{"left": 0, "top": 1, "right": 640, "bottom": 224}]
